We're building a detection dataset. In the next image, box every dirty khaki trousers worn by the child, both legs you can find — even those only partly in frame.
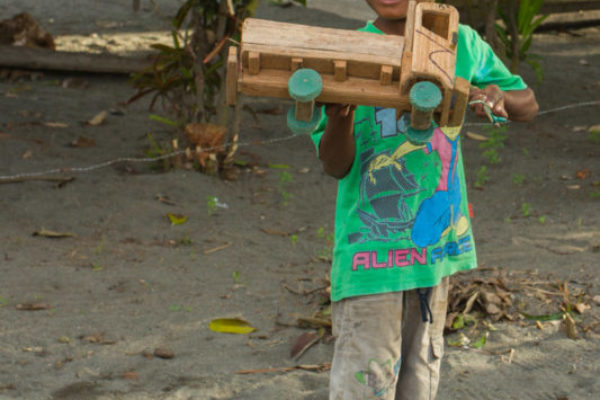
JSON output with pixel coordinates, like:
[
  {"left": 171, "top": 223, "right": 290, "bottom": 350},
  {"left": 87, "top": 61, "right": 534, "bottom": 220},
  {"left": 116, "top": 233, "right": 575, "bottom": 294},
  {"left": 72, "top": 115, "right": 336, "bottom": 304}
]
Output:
[{"left": 329, "top": 277, "right": 448, "bottom": 400}]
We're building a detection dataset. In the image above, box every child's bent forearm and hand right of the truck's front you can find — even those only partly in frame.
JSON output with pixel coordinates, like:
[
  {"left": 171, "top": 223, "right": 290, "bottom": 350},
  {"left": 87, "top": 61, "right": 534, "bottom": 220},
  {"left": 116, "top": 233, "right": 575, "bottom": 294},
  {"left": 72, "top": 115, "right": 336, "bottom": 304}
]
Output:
[{"left": 469, "top": 84, "right": 539, "bottom": 122}]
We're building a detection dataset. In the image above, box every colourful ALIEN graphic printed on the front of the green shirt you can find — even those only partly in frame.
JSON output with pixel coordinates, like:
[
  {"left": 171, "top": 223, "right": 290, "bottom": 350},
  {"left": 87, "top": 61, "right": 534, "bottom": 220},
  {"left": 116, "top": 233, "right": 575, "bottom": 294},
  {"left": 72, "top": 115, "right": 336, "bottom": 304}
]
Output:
[{"left": 348, "top": 108, "right": 471, "bottom": 260}]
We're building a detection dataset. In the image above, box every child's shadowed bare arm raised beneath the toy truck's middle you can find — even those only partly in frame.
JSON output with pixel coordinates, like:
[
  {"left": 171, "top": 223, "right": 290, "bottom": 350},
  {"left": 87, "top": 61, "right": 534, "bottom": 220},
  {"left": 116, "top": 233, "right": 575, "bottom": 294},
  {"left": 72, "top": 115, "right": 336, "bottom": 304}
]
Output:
[{"left": 319, "top": 104, "right": 356, "bottom": 179}]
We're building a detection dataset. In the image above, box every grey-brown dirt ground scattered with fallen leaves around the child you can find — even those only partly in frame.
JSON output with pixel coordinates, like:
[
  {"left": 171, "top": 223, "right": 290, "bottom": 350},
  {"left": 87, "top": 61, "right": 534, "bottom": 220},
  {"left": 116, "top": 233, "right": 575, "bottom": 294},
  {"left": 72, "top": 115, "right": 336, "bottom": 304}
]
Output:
[{"left": 0, "top": 0, "right": 600, "bottom": 400}]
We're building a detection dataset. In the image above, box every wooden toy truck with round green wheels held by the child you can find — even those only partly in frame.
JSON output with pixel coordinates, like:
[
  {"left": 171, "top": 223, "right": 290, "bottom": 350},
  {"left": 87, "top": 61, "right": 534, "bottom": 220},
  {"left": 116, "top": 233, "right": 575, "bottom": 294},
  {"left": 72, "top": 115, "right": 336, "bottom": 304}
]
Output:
[{"left": 227, "top": 0, "right": 470, "bottom": 142}]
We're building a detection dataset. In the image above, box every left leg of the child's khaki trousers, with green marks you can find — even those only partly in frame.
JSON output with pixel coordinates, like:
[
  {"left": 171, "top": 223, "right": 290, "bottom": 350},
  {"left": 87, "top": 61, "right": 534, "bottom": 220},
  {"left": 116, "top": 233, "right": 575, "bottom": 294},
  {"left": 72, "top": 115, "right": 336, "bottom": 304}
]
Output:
[{"left": 329, "top": 292, "right": 403, "bottom": 400}]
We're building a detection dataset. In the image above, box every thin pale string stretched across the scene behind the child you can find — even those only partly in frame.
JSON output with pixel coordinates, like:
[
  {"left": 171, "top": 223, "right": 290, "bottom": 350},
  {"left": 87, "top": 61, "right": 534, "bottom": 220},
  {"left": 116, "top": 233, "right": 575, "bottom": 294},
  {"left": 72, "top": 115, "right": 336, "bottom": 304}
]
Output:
[{"left": 0, "top": 101, "right": 600, "bottom": 181}]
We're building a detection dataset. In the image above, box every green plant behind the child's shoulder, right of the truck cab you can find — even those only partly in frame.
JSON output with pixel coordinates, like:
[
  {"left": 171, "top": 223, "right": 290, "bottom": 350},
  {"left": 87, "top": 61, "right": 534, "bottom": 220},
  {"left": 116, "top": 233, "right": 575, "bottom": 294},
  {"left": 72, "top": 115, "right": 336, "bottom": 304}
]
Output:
[{"left": 496, "top": 0, "right": 548, "bottom": 82}]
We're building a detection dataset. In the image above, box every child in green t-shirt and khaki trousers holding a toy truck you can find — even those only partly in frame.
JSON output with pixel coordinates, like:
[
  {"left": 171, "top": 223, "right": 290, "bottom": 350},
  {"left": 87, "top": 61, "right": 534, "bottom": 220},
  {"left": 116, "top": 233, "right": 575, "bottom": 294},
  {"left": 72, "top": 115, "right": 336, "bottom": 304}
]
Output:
[{"left": 312, "top": 0, "right": 538, "bottom": 400}]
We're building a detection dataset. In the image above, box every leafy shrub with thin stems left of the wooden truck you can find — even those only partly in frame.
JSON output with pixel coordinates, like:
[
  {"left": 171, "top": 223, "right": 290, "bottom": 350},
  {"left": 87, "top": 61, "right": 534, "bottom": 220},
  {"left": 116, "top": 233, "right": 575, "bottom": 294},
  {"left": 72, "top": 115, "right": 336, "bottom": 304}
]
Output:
[{"left": 128, "top": 0, "right": 306, "bottom": 177}]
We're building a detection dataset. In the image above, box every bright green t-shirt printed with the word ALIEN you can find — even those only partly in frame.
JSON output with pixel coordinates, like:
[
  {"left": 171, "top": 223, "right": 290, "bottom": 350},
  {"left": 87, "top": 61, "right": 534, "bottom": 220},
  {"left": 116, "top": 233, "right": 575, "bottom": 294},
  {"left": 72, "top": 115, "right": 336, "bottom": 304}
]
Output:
[{"left": 311, "top": 22, "right": 527, "bottom": 301}]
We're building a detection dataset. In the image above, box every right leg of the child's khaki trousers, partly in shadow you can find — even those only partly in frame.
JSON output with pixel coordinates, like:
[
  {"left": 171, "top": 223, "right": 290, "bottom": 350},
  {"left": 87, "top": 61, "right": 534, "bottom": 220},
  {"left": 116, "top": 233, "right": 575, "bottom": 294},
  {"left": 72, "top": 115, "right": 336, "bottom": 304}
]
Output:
[{"left": 396, "top": 277, "right": 449, "bottom": 400}]
